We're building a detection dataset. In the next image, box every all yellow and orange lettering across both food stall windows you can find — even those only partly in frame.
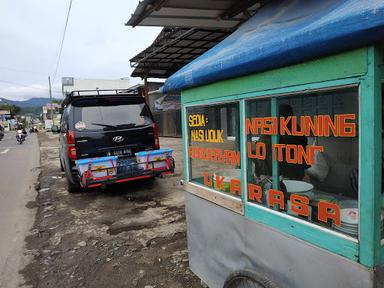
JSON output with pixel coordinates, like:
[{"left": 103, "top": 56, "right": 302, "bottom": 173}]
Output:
[{"left": 188, "top": 114, "right": 356, "bottom": 226}]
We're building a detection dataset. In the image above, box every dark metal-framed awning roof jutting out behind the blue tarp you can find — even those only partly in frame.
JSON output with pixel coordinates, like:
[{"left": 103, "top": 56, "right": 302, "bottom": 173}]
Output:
[{"left": 126, "top": 0, "right": 271, "bottom": 79}]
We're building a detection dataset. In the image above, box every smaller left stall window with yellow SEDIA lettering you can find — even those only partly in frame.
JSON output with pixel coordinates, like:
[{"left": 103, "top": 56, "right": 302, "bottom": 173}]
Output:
[{"left": 187, "top": 103, "right": 241, "bottom": 197}]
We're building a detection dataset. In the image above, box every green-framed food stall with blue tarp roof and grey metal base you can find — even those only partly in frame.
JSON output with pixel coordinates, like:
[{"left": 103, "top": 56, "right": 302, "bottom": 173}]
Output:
[{"left": 162, "top": 0, "right": 384, "bottom": 288}]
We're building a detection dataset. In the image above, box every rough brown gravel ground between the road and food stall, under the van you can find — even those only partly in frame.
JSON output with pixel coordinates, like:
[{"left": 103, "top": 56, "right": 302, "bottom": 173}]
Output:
[{"left": 22, "top": 133, "right": 202, "bottom": 288}]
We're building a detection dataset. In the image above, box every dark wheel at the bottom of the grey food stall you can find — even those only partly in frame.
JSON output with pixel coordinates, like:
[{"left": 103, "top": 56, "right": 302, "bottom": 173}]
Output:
[{"left": 223, "top": 271, "right": 278, "bottom": 288}]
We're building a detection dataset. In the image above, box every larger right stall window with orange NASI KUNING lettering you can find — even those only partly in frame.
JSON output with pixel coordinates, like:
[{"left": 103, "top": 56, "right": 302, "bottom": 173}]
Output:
[{"left": 246, "top": 87, "right": 359, "bottom": 237}]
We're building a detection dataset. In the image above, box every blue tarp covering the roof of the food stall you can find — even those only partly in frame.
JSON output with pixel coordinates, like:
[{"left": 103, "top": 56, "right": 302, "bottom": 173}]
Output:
[{"left": 162, "top": 0, "right": 384, "bottom": 93}]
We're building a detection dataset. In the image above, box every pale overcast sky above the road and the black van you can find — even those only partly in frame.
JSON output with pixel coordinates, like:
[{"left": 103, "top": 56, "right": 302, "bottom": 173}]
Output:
[{"left": 0, "top": 0, "right": 161, "bottom": 100}]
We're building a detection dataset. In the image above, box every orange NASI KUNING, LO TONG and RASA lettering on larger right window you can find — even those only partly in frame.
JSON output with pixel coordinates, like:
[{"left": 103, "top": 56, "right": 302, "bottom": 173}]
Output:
[{"left": 245, "top": 114, "right": 356, "bottom": 226}]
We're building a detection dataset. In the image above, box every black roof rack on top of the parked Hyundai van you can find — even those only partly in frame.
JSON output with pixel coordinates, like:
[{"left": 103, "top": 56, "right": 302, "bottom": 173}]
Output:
[{"left": 61, "top": 88, "right": 141, "bottom": 107}]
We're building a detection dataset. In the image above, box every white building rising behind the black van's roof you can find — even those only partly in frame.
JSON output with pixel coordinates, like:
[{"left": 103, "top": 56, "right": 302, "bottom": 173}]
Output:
[{"left": 61, "top": 77, "right": 129, "bottom": 96}]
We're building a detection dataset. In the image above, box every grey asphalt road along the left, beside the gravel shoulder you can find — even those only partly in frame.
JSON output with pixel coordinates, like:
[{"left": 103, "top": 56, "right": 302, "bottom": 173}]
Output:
[{"left": 0, "top": 132, "right": 40, "bottom": 288}]
